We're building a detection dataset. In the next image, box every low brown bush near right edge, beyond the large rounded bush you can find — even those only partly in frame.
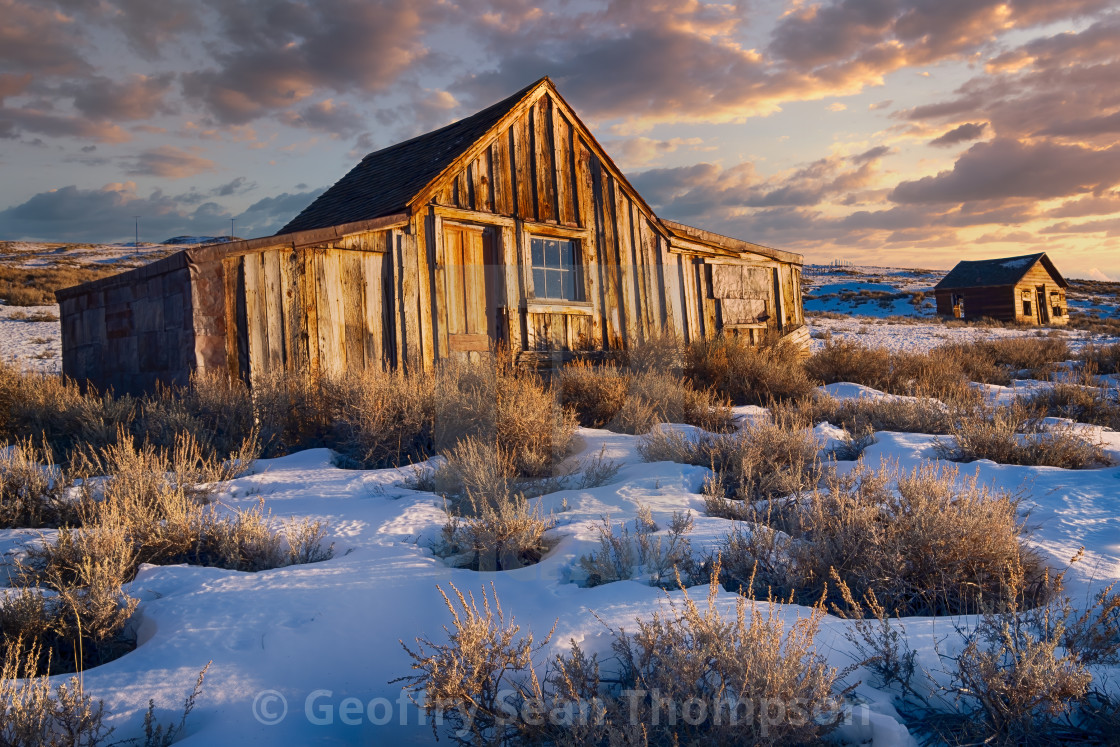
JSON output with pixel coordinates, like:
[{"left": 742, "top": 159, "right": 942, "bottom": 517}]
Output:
[{"left": 934, "top": 401, "right": 1112, "bottom": 469}]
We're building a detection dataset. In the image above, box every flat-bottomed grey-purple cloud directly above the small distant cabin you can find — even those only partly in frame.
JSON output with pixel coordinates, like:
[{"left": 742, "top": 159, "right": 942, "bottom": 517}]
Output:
[{"left": 890, "top": 138, "right": 1120, "bottom": 203}]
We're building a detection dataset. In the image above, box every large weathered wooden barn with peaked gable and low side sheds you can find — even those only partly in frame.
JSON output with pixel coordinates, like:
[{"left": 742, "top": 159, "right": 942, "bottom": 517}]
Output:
[{"left": 58, "top": 78, "right": 808, "bottom": 392}]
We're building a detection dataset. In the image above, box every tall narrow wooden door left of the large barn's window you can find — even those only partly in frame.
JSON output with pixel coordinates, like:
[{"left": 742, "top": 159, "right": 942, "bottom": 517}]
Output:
[{"left": 444, "top": 223, "right": 501, "bottom": 358}]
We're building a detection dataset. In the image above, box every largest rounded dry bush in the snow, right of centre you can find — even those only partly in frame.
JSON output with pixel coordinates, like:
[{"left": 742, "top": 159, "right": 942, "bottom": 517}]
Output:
[{"left": 722, "top": 464, "right": 1047, "bottom": 615}]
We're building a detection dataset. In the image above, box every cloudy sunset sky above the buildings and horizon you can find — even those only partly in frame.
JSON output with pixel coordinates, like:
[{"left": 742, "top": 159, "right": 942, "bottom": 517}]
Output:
[{"left": 0, "top": 0, "right": 1120, "bottom": 280}]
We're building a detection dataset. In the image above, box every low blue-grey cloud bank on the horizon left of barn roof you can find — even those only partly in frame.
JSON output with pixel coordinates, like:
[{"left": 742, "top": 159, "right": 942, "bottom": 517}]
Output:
[{"left": 0, "top": 181, "right": 323, "bottom": 242}]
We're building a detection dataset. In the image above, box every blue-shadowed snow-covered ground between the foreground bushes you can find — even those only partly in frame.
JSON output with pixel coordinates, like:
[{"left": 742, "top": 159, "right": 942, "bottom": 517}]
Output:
[{"left": 0, "top": 384, "right": 1120, "bottom": 746}]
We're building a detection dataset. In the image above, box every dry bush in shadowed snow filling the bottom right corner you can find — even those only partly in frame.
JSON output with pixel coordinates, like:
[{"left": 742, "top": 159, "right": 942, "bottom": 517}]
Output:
[{"left": 838, "top": 564, "right": 1120, "bottom": 745}]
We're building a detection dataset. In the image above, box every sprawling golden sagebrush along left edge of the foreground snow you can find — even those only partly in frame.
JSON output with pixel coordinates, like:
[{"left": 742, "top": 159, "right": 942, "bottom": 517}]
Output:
[{"left": 0, "top": 435, "right": 332, "bottom": 671}]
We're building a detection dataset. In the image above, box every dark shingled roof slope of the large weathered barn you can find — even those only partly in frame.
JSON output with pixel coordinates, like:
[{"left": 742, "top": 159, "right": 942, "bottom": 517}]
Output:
[{"left": 277, "top": 78, "right": 548, "bottom": 235}]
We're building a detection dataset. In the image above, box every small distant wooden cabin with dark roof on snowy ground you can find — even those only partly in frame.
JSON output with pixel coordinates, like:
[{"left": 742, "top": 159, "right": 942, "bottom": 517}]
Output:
[{"left": 933, "top": 252, "right": 1070, "bottom": 325}]
